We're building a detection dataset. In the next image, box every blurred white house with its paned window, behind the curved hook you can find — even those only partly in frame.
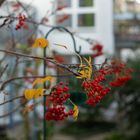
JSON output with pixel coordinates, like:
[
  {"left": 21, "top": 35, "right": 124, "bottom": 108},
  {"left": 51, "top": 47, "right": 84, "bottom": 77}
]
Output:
[{"left": 45, "top": 0, "right": 114, "bottom": 63}]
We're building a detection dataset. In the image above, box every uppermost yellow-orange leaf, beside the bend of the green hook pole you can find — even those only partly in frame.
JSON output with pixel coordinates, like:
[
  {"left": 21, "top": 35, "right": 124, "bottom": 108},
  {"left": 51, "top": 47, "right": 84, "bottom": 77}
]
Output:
[{"left": 32, "top": 37, "right": 49, "bottom": 48}]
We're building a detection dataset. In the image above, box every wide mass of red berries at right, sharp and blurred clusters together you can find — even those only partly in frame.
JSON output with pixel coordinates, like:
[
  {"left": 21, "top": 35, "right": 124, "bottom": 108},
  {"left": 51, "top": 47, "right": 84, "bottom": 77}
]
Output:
[{"left": 82, "top": 60, "right": 133, "bottom": 106}]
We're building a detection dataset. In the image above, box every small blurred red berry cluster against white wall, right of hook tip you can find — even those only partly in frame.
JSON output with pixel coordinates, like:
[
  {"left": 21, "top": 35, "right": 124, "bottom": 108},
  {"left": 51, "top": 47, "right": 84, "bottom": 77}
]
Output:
[{"left": 92, "top": 44, "right": 103, "bottom": 57}]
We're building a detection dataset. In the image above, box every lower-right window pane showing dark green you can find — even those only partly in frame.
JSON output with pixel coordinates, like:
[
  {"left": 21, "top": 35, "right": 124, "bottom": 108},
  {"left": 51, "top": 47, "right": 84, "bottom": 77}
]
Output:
[{"left": 78, "top": 14, "right": 95, "bottom": 27}]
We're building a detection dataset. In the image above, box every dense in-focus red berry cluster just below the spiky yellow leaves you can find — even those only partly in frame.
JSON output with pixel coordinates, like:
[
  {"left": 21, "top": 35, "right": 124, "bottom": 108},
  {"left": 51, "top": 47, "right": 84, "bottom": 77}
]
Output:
[{"left": 82, "top": 72, "right": 110, "bottom": 106}]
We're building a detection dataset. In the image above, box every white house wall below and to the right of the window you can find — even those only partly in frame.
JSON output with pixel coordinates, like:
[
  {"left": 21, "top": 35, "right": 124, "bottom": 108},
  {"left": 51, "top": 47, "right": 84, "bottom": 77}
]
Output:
[{"left": 47, "top": 0, "right": 114, "bottom": 57}]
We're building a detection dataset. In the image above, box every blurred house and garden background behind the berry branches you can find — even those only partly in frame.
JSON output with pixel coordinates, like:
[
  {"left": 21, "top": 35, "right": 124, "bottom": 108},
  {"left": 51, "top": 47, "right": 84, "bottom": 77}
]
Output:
[{"left": 0, "top": 0, "right": 140, "bottom": 140}]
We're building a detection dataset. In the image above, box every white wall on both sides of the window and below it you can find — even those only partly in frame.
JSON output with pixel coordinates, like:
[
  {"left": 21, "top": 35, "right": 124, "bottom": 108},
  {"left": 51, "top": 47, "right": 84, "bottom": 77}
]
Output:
[{"left": 5, "top": 0, "right": 114, "bottom": 54}]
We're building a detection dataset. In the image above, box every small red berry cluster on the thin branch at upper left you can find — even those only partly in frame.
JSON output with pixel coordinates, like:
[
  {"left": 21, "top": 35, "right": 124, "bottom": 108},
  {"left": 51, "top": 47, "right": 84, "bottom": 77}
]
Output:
[{"left": 15, "top": 14, "right": 27, "bottom": 30}]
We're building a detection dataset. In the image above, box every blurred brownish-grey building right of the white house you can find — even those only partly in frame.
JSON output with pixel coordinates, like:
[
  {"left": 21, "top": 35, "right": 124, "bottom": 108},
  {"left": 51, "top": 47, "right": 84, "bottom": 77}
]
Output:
[{"left": 114, "top": 0, "right": 140, "bottom": 59}]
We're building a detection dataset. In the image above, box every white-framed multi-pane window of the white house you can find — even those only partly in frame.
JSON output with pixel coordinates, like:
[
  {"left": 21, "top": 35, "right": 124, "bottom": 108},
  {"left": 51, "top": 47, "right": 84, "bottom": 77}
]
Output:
[{"left": 55, "top": 0, "right": 96, "bottom": 30}]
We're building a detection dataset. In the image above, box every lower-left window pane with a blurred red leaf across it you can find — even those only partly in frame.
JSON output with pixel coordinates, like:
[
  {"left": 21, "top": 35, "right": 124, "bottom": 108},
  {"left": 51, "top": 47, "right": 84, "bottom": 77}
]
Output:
[{"left": 56, "top": 15, "right": 72, "bottom": 27}]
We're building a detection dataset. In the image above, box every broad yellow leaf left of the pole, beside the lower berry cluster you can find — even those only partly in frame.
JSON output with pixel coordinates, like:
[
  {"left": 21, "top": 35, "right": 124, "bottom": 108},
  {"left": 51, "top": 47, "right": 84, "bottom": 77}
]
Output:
[{"left": 24, "top": 89, "right": 45, "bottom": 100}]
